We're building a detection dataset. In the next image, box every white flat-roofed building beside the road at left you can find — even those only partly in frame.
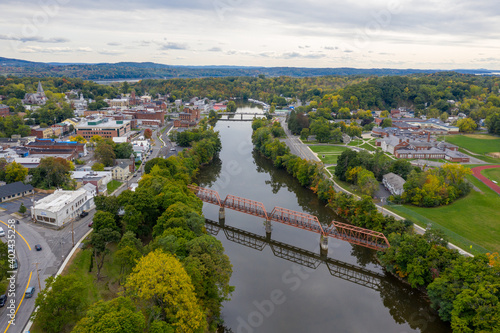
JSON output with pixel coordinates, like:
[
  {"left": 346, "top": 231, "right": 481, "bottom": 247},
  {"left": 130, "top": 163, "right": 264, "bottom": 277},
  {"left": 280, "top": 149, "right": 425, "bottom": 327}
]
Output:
[{"left": 31, "top": 189, "right": 93, "bottom": 227}]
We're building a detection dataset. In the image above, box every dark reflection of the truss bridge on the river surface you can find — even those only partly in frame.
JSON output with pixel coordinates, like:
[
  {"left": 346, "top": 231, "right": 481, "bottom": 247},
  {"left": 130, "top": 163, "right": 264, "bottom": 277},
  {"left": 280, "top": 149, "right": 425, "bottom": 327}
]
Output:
[{"left": 205, "top": 219, "right": 385, "bottom": 291}]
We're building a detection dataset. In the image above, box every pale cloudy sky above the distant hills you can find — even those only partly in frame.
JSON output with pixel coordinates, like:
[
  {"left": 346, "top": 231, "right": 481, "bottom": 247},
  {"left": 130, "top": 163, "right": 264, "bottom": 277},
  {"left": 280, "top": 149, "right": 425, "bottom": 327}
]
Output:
[{"left": 0, "top": 0, "right": 500, "bottom": 70}]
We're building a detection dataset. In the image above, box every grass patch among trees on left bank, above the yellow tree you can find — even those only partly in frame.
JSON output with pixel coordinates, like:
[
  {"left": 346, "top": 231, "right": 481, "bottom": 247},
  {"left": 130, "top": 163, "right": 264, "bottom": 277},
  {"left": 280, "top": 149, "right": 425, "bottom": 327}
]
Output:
[{"left": 30, "top": 245, "right": 121, "bottom": 333}]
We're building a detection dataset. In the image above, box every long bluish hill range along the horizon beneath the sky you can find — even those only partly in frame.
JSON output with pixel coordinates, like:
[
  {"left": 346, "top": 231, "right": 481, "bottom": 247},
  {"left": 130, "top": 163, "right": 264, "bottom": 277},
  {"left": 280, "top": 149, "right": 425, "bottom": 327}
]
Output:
[{"left": 0, "top": 57, "right": 498, "bottom": 80}]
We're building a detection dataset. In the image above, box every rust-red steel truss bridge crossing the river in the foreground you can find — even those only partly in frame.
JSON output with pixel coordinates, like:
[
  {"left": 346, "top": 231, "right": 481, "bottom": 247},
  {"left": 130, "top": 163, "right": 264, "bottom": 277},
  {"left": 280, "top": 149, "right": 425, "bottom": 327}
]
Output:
[{"left": 188, "top": 185, "right": 390, "bottom": 251}]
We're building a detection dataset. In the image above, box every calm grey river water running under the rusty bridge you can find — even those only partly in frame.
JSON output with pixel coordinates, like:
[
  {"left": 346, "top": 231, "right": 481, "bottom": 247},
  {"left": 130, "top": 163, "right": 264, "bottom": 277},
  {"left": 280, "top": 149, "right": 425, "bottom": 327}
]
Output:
[{"left": 198, "top": 107, "right": 451, "bottom": 333}]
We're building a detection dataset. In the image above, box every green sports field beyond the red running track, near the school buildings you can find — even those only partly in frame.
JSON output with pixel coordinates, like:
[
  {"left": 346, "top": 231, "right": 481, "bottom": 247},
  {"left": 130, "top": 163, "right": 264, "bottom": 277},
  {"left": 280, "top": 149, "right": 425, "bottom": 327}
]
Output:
[{"left": 445, "top": 134, "right": 500, "bottom": 163}]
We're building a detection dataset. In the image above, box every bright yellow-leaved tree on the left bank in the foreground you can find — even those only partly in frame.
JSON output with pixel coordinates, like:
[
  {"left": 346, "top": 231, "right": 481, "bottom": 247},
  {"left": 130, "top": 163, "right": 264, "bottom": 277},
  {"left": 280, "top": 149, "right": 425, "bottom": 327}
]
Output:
[{"left": 126, "top": 250, "right": 206, "bottom": 333}]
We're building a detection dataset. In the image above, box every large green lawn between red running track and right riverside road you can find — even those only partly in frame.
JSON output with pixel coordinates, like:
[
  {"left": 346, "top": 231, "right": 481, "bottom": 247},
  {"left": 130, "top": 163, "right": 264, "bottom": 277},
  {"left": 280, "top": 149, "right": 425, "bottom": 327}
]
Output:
[{"left": 386, "top": 176, "right": 500, "bottom": 254}]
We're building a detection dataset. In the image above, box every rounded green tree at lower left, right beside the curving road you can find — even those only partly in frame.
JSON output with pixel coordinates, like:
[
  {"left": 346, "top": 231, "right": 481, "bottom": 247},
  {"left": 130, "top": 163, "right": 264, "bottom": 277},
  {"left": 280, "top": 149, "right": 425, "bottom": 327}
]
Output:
[{"left": 32, "top": 274, "right": 87, "bottom": 333}]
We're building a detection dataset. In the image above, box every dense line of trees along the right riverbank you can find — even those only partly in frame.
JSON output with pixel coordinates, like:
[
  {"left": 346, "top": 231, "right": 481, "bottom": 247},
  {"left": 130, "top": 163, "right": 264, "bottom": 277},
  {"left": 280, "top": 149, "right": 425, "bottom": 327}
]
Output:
[{"left": 252, "top": 118, "right": 500, "bottom": 332}]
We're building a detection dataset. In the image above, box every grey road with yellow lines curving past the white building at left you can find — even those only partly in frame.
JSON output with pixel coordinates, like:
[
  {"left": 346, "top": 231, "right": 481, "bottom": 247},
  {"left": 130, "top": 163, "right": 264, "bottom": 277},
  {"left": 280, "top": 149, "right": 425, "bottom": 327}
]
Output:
[{"left": 0, "top": 123, "right": 181, "bottom": 333}]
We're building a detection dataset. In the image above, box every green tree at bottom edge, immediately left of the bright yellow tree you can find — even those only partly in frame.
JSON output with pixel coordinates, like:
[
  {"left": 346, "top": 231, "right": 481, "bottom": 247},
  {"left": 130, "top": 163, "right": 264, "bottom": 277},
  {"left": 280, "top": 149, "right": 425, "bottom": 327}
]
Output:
[{"left": 72, "top": 297, "right": 146, "bottom": 333}]
